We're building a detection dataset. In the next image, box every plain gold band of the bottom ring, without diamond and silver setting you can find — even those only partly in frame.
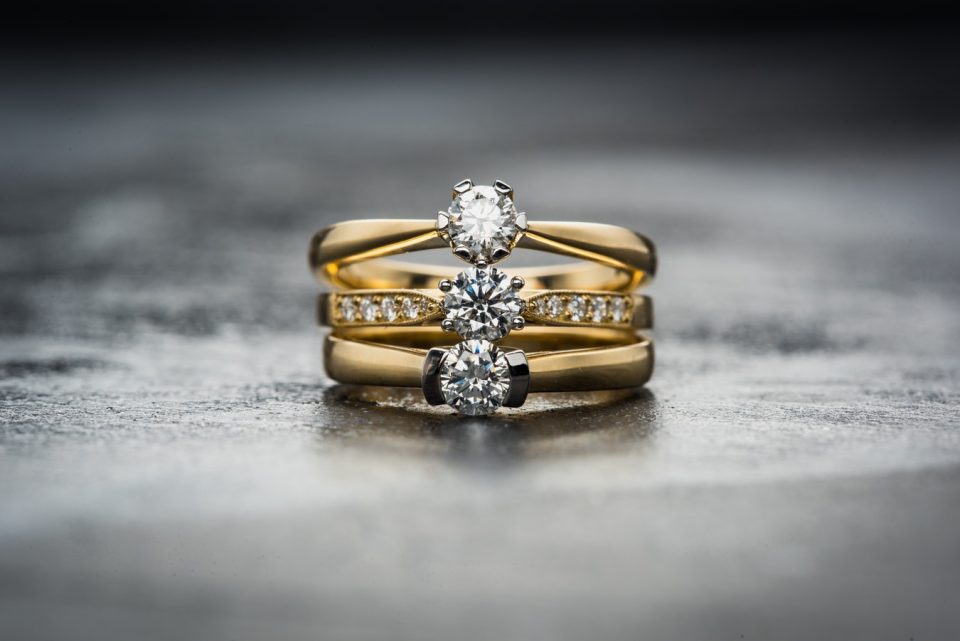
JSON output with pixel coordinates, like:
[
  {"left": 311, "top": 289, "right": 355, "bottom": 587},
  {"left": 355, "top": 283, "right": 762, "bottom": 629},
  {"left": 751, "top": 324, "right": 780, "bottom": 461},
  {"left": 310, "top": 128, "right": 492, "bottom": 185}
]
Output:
[{"left": 324, "top": 327, "right": 654, "bottom": 392}]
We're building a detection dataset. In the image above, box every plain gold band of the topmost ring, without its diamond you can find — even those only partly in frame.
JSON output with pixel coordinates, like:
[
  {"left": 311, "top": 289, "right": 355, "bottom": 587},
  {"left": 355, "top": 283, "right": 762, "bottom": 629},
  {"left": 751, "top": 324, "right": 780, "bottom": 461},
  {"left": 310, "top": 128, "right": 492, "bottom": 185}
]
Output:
[{"left": 310, "top": 219, "right": 657, "bottom": 292}]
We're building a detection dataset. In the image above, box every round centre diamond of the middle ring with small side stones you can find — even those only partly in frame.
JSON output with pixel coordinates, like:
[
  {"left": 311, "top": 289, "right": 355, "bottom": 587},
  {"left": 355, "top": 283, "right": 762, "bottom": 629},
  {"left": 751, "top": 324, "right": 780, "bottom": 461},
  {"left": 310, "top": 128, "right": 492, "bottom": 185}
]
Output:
[{"left": 443, "top": 267, "right": 523, "bottom": 341}]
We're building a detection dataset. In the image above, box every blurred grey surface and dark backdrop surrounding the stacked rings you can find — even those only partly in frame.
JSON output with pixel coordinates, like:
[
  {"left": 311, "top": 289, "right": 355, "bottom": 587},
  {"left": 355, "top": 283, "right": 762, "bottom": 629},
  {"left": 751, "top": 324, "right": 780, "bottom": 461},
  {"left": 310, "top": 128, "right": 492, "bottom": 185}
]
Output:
[{"left": 0, "top": 5, "right": 960, "bottom": 641}]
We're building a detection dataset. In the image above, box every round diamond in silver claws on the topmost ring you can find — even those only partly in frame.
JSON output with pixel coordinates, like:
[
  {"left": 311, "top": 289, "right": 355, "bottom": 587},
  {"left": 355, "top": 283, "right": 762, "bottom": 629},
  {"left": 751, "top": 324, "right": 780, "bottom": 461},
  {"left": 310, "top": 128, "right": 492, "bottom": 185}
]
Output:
[{"left": 441, "top": 185, "right": 526, "bottom": 262}]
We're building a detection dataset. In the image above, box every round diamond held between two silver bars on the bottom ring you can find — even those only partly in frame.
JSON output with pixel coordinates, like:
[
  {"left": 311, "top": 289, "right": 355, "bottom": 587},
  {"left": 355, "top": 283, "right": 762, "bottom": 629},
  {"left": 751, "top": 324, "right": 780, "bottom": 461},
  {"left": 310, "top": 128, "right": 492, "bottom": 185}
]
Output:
[{"left": 440, "top": 340, "right": 510, "bottom": 416}]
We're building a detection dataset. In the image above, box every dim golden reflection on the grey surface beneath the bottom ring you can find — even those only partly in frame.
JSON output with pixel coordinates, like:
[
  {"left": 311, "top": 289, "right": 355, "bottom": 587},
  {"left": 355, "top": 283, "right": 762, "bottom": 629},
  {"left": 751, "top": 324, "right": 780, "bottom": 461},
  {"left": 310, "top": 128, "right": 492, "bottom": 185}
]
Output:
[{"left": 321, "top": 385, "right": 658, "bottom": 466}]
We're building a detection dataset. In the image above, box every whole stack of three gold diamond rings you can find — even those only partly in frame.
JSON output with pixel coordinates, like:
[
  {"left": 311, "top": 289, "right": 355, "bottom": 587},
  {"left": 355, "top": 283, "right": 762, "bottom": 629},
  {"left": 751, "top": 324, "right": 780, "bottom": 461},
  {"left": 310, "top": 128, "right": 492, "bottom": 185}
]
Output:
[{"left": 310, "top": 179, "right": 657, "bottom": 415}]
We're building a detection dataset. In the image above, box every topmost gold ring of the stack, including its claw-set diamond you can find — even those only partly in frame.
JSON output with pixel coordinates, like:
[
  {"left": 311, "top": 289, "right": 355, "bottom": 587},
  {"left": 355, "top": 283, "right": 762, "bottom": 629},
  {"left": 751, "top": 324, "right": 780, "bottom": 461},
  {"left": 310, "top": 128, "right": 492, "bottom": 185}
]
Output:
[{"left": 310, "top": 179, "right": 657, "bottom": 292}]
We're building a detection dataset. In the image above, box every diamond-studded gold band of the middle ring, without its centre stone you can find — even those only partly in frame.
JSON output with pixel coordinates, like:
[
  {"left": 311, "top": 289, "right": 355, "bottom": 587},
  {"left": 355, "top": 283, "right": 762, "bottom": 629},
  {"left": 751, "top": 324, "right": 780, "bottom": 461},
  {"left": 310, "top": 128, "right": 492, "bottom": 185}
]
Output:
[{"left": 317, "top": 289, "right": 653, "bottom": 330}]
